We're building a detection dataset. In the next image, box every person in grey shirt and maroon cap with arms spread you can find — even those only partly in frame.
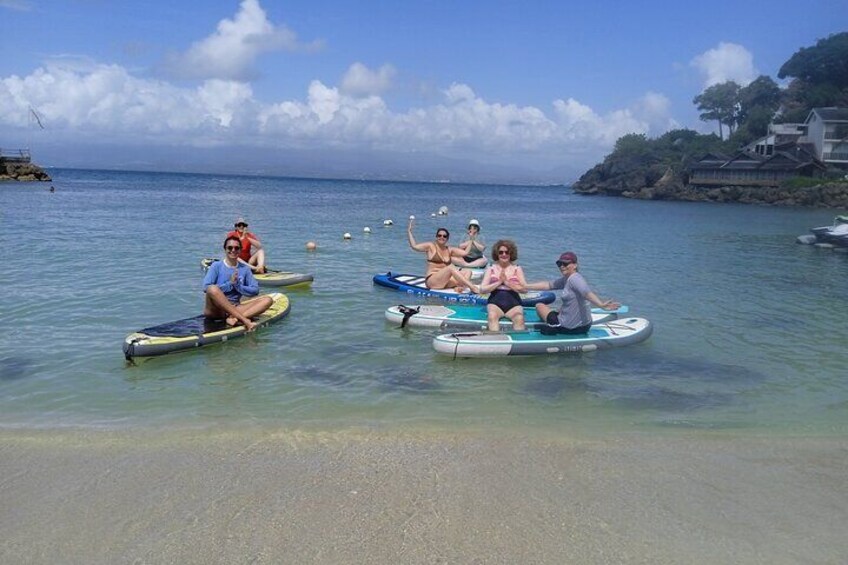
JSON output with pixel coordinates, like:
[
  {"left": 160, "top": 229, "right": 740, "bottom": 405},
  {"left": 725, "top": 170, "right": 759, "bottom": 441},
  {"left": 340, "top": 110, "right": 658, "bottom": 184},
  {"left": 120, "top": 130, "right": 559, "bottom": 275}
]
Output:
[{"left": 527, "top": 251, "right": 621, "bottom": 334}]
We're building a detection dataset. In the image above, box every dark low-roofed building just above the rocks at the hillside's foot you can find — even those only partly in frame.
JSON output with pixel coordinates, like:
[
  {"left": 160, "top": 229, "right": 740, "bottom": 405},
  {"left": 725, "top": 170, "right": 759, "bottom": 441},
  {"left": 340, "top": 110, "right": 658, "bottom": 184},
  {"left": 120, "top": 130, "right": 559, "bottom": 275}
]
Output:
[{"left": 689, "top": 142, "right": 827, "bottom": 186}]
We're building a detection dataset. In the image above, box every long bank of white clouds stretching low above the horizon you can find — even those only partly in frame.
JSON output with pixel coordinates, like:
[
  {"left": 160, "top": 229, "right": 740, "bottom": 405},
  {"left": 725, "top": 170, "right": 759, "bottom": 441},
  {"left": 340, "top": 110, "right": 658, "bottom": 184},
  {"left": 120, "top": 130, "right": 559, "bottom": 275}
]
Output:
[{"left": 0, "top": 60, "right": 673, "bottom": 172}]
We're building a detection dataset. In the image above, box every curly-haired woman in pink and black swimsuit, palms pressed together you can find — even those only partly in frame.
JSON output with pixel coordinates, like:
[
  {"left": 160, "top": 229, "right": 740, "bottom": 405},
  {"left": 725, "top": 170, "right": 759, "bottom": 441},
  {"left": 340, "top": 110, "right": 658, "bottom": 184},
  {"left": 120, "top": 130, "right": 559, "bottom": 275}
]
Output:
[{"left": 480, "top": 239, "right": 527, "bottom": 332}]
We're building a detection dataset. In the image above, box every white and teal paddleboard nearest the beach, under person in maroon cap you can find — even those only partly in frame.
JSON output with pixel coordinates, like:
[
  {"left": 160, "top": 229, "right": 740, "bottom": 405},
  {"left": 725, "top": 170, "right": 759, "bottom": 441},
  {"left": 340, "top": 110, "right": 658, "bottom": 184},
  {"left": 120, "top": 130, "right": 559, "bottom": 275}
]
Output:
[{"left": 433, "top": 318, "right": 653, "bottom": 357}]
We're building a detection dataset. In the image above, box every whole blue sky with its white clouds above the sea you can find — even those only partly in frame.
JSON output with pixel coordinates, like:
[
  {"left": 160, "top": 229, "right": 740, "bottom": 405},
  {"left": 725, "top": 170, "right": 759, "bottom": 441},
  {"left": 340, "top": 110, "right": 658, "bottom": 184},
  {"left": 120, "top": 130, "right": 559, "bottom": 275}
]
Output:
[{"left": 0, "top": 0, "right": 848, "bottom": 183}]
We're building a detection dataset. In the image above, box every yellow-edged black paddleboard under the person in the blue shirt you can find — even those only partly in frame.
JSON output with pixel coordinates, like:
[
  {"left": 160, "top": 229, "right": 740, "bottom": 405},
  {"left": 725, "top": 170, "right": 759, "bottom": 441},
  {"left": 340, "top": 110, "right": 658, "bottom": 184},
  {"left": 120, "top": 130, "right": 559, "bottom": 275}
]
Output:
[{"left": 124, "top": 292, "right": 291, "bottom": 360}]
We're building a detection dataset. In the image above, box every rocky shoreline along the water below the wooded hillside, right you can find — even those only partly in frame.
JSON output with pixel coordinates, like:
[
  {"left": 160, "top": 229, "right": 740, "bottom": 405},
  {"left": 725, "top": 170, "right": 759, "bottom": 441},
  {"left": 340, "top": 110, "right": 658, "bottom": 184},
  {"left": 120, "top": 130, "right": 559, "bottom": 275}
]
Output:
[{"left": 572, "top": 167, "right": 848, "bottom": 209}]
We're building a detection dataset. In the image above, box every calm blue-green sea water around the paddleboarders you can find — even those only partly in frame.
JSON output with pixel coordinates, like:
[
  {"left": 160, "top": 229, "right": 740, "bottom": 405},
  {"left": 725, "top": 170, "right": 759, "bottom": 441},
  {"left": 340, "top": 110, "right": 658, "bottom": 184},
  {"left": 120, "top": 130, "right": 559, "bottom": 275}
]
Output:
[{"left": 0, "top": 170, "right": 848, "bottom": 435}]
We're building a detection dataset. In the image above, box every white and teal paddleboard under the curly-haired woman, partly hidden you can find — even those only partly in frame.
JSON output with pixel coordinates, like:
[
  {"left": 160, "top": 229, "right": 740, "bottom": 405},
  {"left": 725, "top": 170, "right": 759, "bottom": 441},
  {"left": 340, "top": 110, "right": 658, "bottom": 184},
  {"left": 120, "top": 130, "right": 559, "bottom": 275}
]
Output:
[{"left": 386, "top": 304, "right": 630, "bottom": 330}]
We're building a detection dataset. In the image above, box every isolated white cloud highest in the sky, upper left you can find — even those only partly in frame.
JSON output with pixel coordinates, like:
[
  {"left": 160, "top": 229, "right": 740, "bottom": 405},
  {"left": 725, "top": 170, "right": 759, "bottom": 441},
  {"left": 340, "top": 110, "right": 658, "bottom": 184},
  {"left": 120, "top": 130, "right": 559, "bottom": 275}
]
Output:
[{"left": 165, "top": 0, "right": 321, "bottom": 81}]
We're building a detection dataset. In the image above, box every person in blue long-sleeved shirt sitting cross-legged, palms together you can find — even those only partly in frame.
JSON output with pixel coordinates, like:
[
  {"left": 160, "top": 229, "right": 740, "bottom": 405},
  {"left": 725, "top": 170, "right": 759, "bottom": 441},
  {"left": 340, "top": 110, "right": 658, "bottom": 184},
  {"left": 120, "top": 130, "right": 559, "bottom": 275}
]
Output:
[{"left": 203, "top": 236, "right": 273, "bottom": 332}]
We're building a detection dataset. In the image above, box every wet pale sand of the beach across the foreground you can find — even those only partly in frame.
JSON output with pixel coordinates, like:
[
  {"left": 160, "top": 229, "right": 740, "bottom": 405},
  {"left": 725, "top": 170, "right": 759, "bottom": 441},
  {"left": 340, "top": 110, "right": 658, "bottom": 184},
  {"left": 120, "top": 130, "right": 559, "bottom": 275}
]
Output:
[{"left": 0, "top": 430, "right": 848, "bottom": 564}]
